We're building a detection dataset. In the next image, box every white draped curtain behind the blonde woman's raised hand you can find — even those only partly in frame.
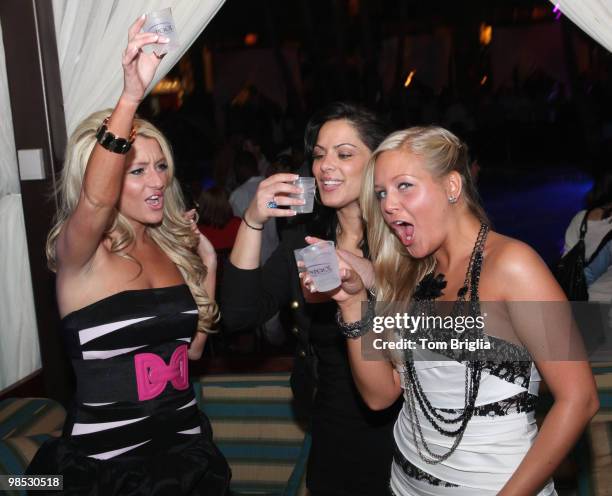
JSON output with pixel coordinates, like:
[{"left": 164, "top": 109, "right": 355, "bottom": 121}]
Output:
[{"left": 53, "top": 0, "right": 224, "bottom": 134}]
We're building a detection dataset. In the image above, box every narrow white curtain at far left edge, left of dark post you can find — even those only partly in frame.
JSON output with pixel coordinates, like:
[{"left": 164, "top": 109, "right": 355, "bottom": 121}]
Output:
[{"left": 0, "top": 20, "right": 40, "bottom": 390}]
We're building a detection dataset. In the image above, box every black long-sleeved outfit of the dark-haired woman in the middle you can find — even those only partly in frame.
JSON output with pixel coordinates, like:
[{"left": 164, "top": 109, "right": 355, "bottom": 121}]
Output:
[{"left": 221, "top": 226, "right": 400, "bottom": 496}]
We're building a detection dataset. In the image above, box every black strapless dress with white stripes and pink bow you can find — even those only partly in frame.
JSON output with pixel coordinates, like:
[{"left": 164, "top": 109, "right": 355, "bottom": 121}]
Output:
[{"left": 27, "top": 285, "right": 230, "bottom": 496}]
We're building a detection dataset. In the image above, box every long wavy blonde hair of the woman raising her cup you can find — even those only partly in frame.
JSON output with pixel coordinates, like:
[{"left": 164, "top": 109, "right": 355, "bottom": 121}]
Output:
[{"left": 46, "top": 109, "right": 219, "bottom": 332}]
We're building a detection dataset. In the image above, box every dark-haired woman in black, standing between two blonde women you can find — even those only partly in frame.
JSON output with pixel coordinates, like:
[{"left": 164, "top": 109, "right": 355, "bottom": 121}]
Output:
[{"left": 221, "top": 103, "right": 399, "bottom": 496}]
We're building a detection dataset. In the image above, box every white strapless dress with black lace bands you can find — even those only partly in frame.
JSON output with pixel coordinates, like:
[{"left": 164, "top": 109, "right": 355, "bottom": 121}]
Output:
[{"left": 391, "top": 360, "right": 556, "bottom": 496}]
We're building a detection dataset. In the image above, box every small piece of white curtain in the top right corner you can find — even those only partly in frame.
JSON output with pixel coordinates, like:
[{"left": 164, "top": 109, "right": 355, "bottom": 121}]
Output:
[{"left": 550, "top": 0, "right": 612, "bottom": 51}]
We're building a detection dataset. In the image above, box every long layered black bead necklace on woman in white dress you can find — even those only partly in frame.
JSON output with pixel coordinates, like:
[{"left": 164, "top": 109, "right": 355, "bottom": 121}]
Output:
[{"left": 404, "top": 223, "right": 489, "bottom": 465}]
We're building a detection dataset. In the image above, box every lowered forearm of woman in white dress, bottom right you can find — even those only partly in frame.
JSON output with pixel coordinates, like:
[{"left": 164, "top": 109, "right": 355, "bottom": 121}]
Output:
[{"left": 499, "top": 398, "right": 598, "bottom": 496}]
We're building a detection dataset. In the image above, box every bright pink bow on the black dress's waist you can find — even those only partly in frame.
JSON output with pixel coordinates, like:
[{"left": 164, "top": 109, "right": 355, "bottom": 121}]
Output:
[{"left": 134, "top": 344, "right": 189, "bottom": 401}]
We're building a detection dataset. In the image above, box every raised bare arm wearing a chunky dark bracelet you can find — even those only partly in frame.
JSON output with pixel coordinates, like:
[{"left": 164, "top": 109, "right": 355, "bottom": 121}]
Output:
[{"left": 56, "top": 16, "right": 167, "bottom": 272}]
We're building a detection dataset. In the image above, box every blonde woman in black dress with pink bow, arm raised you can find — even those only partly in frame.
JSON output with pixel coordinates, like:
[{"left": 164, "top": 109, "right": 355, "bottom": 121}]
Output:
[{"left": 23, "top": 16, "right": 229, "bottom": 496}]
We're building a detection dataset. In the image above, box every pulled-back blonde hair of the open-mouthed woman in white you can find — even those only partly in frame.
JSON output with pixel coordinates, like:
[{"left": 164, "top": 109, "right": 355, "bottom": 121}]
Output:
[{"left": 359, "top": 126, "right": 489, "bottom": 302}]
